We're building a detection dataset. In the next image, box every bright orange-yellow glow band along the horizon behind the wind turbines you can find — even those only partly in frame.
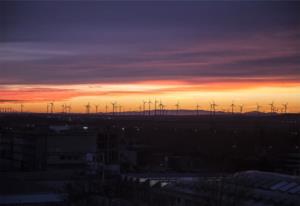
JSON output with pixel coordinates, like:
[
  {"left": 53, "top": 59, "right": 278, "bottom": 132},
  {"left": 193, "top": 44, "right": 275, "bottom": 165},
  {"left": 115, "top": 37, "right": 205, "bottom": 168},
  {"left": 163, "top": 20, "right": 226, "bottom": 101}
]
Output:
[{"left": 0, "top": 80, "right": 300, "bottom": 113}]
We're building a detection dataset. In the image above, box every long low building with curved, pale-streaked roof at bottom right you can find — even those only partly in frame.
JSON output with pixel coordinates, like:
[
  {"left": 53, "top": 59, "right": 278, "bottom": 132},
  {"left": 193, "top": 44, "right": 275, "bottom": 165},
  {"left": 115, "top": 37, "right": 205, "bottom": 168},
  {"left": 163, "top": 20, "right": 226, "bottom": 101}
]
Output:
[{"left": 122, "top": 171, "right": 300, "bottom": 206}]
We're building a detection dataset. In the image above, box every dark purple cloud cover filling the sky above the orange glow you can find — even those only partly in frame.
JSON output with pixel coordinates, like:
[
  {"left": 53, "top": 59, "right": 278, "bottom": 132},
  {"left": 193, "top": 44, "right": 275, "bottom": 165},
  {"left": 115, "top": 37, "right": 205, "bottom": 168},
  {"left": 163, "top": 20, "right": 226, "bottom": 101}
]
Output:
[{"left": 0, "top": 2, "right": 300, "bottom": 85}]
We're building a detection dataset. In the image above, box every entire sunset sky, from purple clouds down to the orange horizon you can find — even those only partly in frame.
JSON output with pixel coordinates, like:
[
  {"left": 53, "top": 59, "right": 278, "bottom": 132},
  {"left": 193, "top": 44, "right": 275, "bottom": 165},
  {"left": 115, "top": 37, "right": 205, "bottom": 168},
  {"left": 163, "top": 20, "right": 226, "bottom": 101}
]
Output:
[{"left": 0, "top": 1, "right": 300, "bottom": 112}]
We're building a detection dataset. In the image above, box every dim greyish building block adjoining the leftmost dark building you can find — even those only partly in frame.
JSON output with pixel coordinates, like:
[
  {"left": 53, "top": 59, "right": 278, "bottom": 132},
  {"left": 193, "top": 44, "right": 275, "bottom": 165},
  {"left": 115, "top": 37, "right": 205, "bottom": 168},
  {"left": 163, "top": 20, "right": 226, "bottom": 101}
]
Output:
[{"left": 47, "top": 126, "right": 102, "bottom": 170}]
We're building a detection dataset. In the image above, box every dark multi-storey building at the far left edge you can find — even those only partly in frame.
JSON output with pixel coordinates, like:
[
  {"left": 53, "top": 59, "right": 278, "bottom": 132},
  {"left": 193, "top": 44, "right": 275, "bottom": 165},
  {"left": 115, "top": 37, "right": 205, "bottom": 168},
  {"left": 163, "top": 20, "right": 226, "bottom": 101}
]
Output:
[{"left": 0, "top": 128, "right": 47, "bottom": 171}]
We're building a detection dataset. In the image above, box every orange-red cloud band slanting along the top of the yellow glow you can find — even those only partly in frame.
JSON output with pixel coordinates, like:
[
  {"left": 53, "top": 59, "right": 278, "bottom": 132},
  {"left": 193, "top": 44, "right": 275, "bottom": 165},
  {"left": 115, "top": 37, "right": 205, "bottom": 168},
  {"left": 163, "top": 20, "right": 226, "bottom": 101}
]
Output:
[{"left": 0, "top": 79, "right": 300, "bottom": 103}]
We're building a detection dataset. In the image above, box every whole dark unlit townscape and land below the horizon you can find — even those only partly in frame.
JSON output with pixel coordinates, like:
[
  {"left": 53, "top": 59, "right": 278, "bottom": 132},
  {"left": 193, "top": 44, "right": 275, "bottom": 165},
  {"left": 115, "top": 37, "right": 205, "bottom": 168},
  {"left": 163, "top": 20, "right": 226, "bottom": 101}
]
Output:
[{"left": 0, "top": 114, "right": 300, "bottom": 206}]
